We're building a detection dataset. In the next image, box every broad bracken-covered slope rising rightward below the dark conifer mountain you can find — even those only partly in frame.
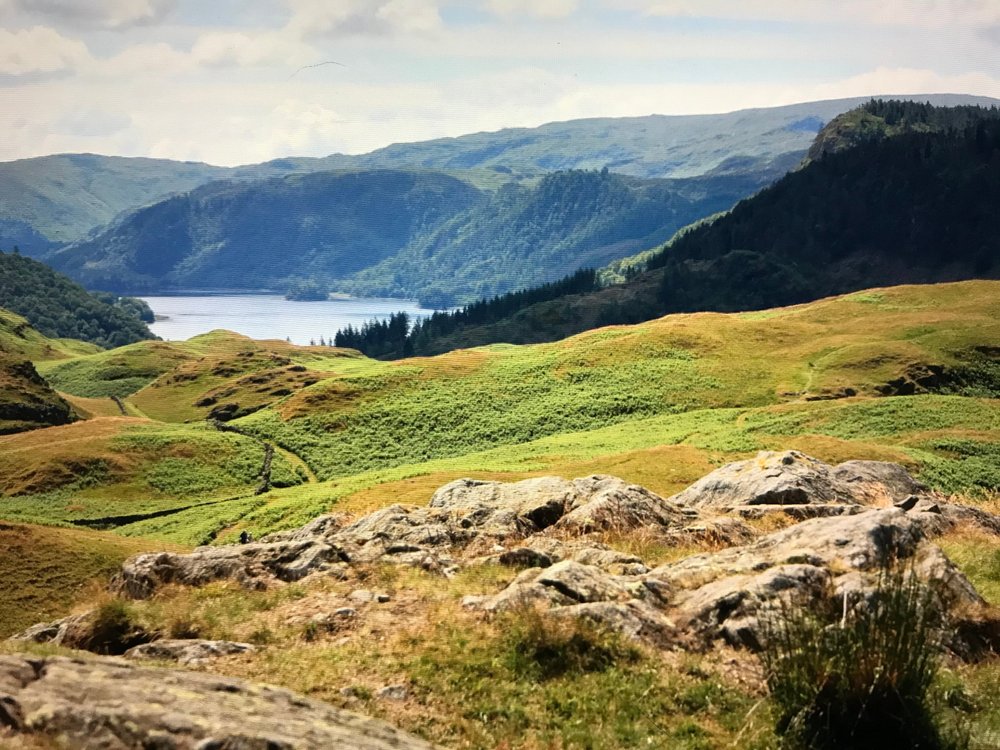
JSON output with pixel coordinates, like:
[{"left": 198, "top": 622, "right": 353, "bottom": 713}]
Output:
[{"left": 243, "top": 282, "right": 1000, "bottom": 478}]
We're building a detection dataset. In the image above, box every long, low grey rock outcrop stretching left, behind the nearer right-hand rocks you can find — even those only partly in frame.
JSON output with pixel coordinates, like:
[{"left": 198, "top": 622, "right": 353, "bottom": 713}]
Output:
[{"left": 112, "top": 476, "right": 751, "bottom": 598}]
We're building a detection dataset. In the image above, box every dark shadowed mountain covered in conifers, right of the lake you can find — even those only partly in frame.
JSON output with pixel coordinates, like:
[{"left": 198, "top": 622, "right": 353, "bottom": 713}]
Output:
[{"left": 342, "top": 101, "right": 1000, "bottom": 357}]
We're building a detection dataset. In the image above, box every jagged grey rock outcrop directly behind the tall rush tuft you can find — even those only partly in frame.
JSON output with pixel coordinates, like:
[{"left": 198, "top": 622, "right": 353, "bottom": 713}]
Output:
[{"left": 465, "top": 507, "right": 985, "bottom": 648}]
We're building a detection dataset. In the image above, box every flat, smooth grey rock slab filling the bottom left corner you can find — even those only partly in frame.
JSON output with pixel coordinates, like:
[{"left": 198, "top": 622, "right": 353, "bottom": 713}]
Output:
[{"left": 0, "top": 656, "right": 431, "bottom": 750}]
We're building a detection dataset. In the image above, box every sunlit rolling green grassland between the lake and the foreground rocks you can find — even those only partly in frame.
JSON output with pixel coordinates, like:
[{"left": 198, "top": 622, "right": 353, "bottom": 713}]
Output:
[{"left": 0, "top": 282, "right": 1000, "bottom": 544}]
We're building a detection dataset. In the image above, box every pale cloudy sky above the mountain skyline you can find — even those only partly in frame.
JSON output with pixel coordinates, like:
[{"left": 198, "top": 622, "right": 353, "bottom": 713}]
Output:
[{"left": 0, "top": 0, "right": 1000, "bottom": 165}]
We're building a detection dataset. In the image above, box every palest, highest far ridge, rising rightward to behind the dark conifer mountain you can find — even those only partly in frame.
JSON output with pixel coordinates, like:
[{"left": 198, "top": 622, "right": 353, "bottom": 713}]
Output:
[{"left": 308, "top": 94, "right": 998, "bottom": 178}]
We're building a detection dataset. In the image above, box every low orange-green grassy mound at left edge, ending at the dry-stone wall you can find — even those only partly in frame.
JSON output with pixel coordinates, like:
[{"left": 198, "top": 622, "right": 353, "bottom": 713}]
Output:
[{"left": 0, "top": 417, "right": 304, "bottom": 523}]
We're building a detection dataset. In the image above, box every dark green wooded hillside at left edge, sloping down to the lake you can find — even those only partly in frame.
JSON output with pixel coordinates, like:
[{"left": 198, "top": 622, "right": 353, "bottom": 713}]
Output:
[{"left": 0, "top": 252, "right": 153, "bottom": 347}]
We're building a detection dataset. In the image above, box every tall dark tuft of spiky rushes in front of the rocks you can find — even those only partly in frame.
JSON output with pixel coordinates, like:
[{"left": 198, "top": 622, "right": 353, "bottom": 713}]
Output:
[{"left": 761, "top": 567, "right": 953, "bottom": 750}]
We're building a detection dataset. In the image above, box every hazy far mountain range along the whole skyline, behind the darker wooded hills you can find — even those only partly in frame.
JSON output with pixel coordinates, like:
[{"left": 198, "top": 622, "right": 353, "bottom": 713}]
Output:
[{"left": 0, "top": 95, "right": 994, "bottom": 256}]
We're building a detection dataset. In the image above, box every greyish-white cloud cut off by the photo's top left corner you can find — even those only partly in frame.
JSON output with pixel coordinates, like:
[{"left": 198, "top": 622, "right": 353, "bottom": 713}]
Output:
[{"left": 6, "top": 0, "right": 177, "bottom": 29}]
